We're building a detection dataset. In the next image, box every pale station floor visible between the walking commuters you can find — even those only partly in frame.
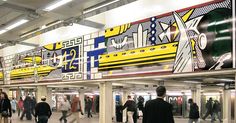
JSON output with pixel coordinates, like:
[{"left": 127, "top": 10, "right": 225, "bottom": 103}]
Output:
[{"left": 6, "top": 113, "right": 229, "bottom": 123}]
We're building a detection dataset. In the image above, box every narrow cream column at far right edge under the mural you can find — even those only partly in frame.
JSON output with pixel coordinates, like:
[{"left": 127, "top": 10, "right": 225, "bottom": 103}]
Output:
[{"left": 223, "top": 90, "right": 231, "bottom": 123}]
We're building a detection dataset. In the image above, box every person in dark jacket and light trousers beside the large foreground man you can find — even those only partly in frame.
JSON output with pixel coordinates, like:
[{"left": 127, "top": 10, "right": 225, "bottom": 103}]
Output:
[{"left": 122, "top": 95, "right": 137, "bottom": 123}]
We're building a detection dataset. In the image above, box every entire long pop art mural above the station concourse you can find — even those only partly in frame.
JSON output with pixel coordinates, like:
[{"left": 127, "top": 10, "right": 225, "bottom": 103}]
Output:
[{"left": 0, "top": 0, "right": 234, "bottom": 82}]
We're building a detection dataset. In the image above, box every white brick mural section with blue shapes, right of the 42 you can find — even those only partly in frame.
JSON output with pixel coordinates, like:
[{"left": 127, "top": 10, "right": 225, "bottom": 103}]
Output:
[{"left": 83, "top": 32, "right": 106, "bottom": 80}]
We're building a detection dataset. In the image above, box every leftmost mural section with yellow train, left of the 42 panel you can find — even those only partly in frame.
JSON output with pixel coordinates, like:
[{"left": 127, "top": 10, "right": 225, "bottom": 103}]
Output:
[{"left": 0, "top": 42, "right": 62, "bottom": 83}]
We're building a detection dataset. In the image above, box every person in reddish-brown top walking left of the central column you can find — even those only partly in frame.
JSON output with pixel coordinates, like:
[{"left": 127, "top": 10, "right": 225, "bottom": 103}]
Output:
[{"left": 70, "top": 96, "right": 83, "bottom": 123}]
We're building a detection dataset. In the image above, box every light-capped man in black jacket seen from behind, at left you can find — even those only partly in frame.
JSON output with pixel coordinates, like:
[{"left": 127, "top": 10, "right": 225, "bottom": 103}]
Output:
[{"left": 35, "top": 96, "right": 52, "bottom": 123}]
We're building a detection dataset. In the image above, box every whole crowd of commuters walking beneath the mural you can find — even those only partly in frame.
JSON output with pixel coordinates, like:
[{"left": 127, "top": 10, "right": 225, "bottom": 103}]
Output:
[{"left": 0, "top": 86, "right": 222, "bottom": 123}]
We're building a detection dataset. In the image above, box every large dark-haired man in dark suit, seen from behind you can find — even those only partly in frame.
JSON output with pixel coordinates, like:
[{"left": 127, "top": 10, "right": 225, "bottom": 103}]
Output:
[{"left": 143, "top": 86, "right": 174, "bottom": 123}]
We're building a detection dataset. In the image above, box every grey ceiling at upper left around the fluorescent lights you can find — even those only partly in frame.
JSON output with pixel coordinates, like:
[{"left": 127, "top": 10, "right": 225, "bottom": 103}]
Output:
[{"left": 0, "top": 0, "right": 105, "bottom": 41}]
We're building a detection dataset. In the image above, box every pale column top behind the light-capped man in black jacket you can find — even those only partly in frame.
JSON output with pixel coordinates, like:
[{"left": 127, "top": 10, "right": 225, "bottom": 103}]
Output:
[{"left": 36, "top": 85, "right": 47, "bottom": 102}]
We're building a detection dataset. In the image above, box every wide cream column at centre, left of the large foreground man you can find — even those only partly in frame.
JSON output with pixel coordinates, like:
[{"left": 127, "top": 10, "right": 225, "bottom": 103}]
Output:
[{"left": 99, "top": 82, "right": 112, "bottom": 123}]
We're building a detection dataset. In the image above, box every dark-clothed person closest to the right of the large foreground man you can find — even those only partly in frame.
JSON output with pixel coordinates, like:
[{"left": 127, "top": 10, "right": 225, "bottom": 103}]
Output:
[{"left": 188, "top": 99, "right": 199, "bottom": 123}]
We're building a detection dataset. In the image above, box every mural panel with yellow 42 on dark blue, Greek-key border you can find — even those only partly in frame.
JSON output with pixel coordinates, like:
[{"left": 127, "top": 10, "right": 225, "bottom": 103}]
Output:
[{"left": 61, "top": 37, "right": 83, "bottom": 80}]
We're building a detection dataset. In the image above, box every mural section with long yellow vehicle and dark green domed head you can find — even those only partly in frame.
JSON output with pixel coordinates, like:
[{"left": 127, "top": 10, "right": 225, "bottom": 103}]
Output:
[{"left": 99, "top": 0, "right": 233, "bottom": 76}]
